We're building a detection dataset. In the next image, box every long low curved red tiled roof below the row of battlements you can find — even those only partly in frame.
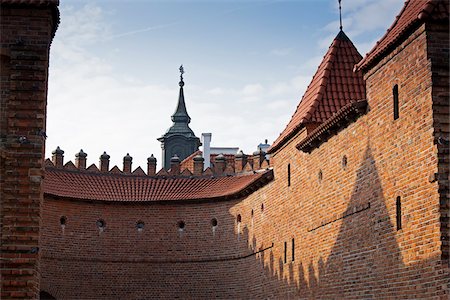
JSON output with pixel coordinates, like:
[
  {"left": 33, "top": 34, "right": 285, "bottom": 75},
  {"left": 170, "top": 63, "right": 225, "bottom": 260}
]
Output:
[{"left": 44, "top": 167, "right": 273, "bottom": 202}]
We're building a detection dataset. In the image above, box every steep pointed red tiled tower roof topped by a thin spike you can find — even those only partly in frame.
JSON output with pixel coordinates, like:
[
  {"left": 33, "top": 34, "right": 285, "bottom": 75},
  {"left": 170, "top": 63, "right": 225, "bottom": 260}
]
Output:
[{"left": 268, "top": 31, "right": 365, "bottom": 153}]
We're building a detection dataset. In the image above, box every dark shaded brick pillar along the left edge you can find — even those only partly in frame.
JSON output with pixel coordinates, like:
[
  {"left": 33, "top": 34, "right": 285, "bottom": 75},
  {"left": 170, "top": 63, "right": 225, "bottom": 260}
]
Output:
[{"left": 0, "top": 5, "right": 55, "bottom": 299}]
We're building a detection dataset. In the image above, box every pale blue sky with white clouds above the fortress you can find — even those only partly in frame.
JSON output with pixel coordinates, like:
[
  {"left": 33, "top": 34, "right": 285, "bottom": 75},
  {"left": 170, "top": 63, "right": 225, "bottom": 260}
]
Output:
[{"left": 46, "top": 0, "right": 403, "bottom": 170}]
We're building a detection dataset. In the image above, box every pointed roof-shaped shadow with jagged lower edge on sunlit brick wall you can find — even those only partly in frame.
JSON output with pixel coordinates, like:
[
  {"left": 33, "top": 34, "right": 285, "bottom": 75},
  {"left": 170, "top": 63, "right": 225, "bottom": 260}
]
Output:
[{"left": 234, "top": 145, "right": 448, "bottom": 299}]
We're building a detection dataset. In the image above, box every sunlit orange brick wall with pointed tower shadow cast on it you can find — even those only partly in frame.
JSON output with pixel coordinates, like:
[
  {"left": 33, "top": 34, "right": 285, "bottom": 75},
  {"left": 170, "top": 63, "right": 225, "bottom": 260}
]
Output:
[{"left": 232, "top": 26, "right": 449, "bottom": 299}]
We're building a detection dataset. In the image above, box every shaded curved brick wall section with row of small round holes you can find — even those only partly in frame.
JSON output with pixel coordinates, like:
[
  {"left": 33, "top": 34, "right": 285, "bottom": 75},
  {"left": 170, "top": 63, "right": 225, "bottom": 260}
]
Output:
[{"left": 41, "top": 197, "right": 274, "bottom": 299}]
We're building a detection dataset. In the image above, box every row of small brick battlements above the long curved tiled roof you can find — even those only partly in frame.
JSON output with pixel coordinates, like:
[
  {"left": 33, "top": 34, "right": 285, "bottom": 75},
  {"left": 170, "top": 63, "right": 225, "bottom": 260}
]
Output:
[{"left": 45, "top": 146, "right": 270, "bottom": 177}]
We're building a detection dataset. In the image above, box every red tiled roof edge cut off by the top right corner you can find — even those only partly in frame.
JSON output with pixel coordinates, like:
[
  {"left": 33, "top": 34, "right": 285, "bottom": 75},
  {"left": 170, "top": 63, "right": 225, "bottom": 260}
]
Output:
[{"left": 356, "top": 0, "right": 449, "bottom": 70}]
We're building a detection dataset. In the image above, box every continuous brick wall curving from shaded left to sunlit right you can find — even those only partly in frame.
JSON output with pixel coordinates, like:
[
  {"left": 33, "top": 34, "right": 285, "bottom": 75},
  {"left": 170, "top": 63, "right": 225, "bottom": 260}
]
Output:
[{"left": 37, "top": 18, "right": 449, "bottom": 299}]
